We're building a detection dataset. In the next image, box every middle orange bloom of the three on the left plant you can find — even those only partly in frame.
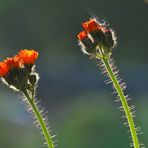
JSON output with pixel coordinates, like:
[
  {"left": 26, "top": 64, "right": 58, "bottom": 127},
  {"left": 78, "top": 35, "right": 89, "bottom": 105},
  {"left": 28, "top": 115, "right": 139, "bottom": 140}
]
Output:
[{"left": 4, "top": 55, "right": 23, "bottom": 69}]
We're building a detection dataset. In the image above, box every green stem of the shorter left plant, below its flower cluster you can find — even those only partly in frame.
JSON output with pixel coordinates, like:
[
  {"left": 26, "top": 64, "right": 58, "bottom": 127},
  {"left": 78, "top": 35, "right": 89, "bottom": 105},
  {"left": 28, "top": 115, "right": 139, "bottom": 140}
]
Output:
[{"left": 24, "top": 92, "right": 54, "bottom": 148}]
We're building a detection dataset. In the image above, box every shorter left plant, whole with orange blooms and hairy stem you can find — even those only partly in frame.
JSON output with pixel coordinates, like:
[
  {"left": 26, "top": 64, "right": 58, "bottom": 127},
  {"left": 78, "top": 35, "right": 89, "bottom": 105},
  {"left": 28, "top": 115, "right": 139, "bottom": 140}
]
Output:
[{"left": 0, "top": 49, "right": 54, "bottom": 148}]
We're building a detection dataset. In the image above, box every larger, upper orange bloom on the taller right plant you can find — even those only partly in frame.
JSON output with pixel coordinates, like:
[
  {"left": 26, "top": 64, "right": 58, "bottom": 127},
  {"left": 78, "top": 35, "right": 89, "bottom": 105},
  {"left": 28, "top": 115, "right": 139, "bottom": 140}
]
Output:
[{"left": 82, "top": 19, "right": 101, "bottom": 33}]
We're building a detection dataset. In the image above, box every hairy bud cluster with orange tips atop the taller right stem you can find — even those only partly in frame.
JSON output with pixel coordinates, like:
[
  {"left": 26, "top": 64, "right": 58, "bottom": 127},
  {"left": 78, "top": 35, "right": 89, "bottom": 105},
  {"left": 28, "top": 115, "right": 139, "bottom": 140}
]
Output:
[{"left": 78, "top": 19, "right": 116, "bottom": 54}]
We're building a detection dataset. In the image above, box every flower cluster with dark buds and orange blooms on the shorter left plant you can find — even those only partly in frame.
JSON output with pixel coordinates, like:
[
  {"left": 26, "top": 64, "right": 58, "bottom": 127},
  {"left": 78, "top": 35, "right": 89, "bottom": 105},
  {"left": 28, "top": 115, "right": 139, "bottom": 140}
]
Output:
[{"left": 0, "top": 49, "right": 38, "bottom": 91}]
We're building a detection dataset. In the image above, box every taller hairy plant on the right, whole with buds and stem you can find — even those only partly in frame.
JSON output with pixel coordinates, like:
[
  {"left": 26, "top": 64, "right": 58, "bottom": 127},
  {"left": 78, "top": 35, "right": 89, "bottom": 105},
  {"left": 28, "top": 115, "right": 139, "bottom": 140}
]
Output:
[{"left": 78, "top": 18, "right": 144, "bottom": 148}]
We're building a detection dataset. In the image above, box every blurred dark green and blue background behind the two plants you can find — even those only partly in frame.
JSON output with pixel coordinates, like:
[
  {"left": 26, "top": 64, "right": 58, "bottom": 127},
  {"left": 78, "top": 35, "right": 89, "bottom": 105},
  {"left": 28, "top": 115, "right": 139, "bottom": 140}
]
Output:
[{"left": 0, "top": 0, "right": 148, "bottom": 148}]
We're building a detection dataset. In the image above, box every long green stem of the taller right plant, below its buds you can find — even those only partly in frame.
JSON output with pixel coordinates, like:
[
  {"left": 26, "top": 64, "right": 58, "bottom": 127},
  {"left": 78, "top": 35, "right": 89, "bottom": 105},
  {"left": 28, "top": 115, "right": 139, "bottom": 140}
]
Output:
[{"left": 101, "top": 56, "right": 140, "bottom": 148}]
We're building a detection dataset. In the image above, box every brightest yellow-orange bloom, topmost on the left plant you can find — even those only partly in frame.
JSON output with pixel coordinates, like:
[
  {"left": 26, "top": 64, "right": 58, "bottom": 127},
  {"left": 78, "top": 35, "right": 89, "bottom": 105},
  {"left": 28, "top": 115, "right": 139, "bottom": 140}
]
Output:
[{"left": 18, "top": 49, "right": 38, "bottom": 64}]
